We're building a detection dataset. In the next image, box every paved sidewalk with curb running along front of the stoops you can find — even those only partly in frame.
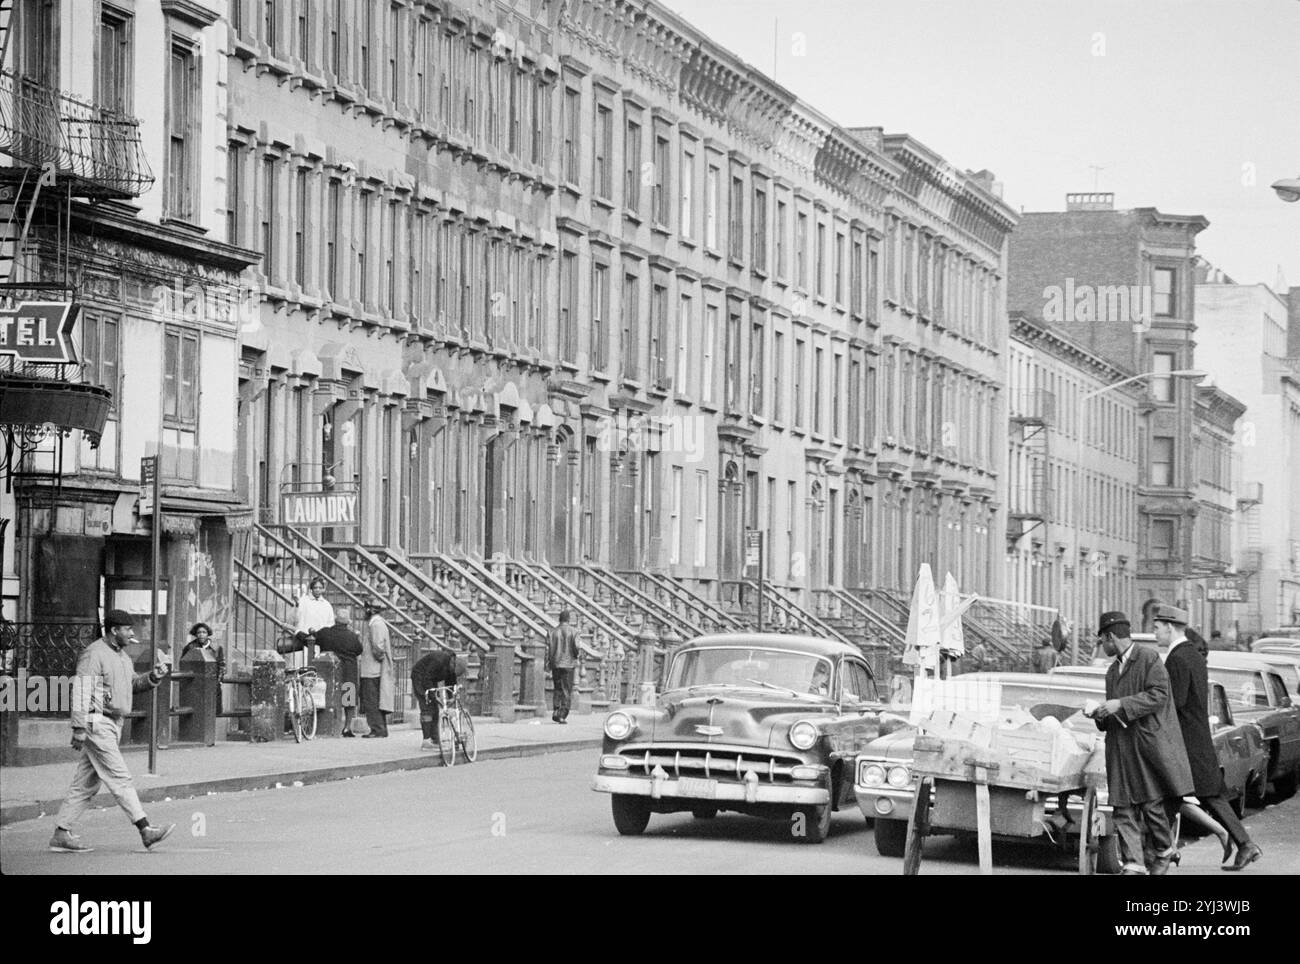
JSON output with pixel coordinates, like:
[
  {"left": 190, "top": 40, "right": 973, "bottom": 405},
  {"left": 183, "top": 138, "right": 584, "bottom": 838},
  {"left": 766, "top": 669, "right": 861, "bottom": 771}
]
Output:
[{"left": 0, "top": 713, "right": 605, "bottom": 824}]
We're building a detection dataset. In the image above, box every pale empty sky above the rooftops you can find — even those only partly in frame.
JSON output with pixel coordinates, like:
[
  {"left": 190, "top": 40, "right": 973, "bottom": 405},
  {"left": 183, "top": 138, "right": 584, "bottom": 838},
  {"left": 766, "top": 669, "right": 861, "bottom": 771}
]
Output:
[{"left": 662, "top": 0, "right": 1300, "bottom": 286}]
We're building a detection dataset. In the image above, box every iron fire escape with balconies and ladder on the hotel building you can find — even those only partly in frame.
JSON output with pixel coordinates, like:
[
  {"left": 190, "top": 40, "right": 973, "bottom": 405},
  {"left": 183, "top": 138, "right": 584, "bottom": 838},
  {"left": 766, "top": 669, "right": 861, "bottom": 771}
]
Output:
[{"left": 0, "top": 0, "right": 153, "bottom": 485}]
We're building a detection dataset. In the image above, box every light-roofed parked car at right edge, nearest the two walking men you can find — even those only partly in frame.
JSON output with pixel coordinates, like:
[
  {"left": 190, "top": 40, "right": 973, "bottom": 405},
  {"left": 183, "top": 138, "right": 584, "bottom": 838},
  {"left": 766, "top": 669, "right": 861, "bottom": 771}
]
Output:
[{"left": 1206, "top": 652, "right": 1300, "bottom": 798}]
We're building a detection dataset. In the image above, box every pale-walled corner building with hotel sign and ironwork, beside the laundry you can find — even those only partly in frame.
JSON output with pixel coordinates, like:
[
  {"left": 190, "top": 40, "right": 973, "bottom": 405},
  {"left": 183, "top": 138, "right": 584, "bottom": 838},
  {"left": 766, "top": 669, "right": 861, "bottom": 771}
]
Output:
[{"left": 0, "top": 0, "right": 257, "bottom": 657}]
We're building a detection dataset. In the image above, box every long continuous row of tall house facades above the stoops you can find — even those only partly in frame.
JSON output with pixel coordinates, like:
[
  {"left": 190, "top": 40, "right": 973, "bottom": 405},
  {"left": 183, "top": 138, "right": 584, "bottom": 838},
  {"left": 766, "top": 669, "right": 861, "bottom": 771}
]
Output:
[{"left": 221, "top": 0, "right": 1015, "bottom": 657}]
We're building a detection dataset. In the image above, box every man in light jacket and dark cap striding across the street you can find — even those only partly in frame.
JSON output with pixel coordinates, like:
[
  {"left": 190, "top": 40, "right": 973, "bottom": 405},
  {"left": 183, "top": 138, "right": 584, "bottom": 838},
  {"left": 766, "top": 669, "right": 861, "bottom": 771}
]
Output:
[{"left": 49, "top": 609, "right": 176, "bottom": 854}]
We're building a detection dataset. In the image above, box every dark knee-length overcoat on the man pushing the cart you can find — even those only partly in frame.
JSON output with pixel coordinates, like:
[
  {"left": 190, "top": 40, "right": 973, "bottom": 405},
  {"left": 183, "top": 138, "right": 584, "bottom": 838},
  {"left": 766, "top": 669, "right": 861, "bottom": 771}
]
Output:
[{"left": 1097, "top": 643, "right": 1192, "bottom": 807}]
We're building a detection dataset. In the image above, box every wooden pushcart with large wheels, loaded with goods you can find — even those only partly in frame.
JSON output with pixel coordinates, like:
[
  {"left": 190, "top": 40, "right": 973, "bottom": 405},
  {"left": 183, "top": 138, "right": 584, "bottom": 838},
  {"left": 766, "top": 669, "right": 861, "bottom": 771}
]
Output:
[{"left": 904, "top": 735, "right": 1118, "bottom": 876}]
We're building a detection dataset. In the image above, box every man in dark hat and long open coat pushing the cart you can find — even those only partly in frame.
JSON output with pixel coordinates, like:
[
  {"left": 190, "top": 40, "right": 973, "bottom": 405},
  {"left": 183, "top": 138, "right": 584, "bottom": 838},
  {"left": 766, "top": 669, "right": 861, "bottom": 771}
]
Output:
[{"left": 1092, "top": 612, "right": 1192, "bottom": 874}]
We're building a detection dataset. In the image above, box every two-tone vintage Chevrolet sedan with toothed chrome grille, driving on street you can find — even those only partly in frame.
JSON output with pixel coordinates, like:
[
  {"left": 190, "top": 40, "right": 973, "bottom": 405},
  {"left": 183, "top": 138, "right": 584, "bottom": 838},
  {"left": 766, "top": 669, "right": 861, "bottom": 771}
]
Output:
[{"left": 592, "top": 633, "right": 883, "bottom": 843}]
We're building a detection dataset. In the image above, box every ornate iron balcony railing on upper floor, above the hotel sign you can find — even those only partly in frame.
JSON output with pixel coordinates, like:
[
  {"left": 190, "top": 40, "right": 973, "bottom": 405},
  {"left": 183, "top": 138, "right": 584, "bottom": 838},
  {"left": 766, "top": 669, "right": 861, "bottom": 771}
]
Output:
[{"left": 0, "top": 70, "right": 153, "bottom": 197}]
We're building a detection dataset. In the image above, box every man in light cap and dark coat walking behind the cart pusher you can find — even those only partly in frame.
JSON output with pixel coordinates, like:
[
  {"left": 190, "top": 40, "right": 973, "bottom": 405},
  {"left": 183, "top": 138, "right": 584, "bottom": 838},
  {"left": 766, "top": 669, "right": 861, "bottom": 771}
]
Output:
[{"left": 1154, "top": 605, "right": 1264, "bottom": 870}]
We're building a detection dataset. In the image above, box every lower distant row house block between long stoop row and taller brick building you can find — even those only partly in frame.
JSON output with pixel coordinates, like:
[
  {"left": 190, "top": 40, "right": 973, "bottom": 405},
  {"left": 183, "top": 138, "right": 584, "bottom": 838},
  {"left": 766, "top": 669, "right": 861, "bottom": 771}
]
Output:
[{"left": 1006, "top": 313, "right": 1148, "bottom": 638}]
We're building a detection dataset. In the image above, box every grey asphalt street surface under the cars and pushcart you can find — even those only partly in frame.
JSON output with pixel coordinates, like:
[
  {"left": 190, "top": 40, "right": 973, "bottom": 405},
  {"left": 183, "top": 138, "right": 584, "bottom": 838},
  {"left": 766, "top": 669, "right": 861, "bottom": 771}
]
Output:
[{"left": 0, "top": 751, "right": 1300, "bottom": 876}]
